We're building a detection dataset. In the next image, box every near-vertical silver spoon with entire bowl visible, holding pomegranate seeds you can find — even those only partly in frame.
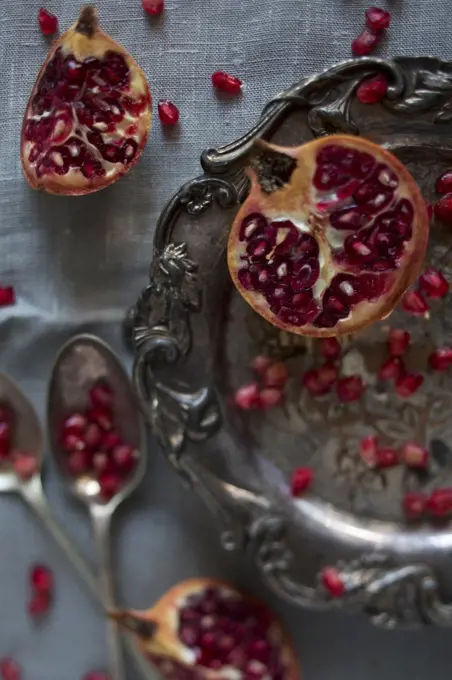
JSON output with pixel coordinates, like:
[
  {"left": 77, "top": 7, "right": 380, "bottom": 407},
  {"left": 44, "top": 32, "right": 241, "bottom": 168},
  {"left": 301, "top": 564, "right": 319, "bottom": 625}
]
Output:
[{"left": 47, "top": 335, "right": 146, "bottom": 680}]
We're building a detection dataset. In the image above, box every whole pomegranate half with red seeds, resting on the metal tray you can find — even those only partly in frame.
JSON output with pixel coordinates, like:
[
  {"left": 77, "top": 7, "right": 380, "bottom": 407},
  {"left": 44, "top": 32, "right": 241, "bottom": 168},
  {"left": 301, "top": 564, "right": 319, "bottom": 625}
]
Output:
[{"left": 228, "top": 135, "right": 429, "bottom": 337}]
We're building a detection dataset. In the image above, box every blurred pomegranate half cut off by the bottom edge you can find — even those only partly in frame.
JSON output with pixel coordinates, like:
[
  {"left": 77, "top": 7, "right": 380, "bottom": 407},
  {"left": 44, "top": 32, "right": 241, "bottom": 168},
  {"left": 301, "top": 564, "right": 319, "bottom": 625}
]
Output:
[{"left": 110, "top": 578, "right": 300, "bottom": 680}]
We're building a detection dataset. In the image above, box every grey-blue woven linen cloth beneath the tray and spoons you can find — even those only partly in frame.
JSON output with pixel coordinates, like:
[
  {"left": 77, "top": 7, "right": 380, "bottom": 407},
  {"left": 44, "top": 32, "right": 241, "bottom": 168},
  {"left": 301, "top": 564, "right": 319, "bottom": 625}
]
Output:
[{"left": 0, "top": 0, "right": 452, "bottom": 680}]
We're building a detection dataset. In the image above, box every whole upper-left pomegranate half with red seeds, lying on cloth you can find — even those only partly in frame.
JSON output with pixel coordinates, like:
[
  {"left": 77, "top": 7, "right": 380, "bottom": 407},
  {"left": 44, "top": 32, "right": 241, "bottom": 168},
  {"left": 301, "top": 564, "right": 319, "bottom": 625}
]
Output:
[{"left": 21, "top": 7, "right": 151, "bottom": 196}]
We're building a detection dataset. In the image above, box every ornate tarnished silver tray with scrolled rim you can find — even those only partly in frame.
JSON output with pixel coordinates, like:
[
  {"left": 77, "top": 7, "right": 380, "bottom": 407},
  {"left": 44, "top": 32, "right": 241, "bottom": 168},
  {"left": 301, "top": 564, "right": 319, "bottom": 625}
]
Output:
[{"left": 126, "top": 58, "right": 452, "bottom": 627}]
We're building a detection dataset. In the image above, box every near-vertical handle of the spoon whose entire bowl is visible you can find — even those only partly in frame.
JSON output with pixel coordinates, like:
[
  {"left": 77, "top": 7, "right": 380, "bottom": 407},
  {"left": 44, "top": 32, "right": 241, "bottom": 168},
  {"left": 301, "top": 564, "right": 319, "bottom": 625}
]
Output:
[{"left": 90, "top": 504, "right": 126, "bottom": 680}]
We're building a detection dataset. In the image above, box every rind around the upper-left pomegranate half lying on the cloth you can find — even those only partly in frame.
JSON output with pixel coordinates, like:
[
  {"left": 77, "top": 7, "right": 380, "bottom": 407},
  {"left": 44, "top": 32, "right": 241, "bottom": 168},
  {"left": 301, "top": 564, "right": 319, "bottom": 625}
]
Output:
[{"left": 20, "top": 7, "right": 152, "bottom": 196}]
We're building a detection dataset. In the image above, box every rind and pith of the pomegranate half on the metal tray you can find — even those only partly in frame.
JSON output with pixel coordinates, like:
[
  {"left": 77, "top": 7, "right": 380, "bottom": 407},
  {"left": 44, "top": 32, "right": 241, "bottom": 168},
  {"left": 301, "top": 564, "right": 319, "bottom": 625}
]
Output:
[{"left": 228, "top": 135, "right": 429, "bottom": 338}]
